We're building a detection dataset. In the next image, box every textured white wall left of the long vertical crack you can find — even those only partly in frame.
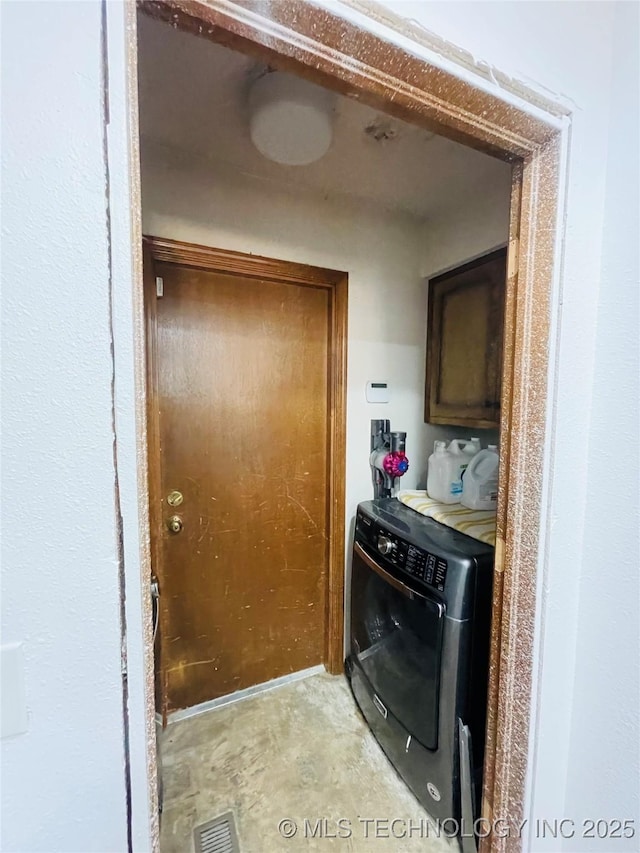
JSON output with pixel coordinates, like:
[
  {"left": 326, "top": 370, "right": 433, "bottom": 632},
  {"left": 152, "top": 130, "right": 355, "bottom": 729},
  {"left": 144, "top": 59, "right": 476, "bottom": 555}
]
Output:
[{"left": 1, "top": 3, "right": 130, "bottom": 853}]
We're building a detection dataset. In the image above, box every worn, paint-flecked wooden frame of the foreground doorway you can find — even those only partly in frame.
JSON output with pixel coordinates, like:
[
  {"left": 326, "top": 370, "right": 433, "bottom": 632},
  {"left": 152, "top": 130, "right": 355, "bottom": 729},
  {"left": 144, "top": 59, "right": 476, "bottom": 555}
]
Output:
[{"left": 129, "top": 0, "right": 570, "bottom": 853}]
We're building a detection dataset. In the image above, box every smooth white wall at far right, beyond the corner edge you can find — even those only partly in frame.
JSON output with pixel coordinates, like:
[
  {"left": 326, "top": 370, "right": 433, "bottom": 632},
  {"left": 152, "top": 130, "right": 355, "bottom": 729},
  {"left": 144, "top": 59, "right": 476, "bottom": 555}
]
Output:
[{"left": 566, "top": 3, "right": 640, "bottom": 853}]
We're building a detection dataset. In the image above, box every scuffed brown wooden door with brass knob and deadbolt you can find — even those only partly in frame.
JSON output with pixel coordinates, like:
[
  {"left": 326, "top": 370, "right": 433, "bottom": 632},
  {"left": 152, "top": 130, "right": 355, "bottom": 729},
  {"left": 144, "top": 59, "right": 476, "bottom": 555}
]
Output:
[{"left": 147, "top": 238, "right": 344, "bottom": 712}]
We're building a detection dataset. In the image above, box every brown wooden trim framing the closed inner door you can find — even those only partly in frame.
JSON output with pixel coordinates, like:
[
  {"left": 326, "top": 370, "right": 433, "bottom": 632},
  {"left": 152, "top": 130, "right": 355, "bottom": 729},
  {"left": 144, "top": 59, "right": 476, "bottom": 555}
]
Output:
[{"left": 143, "top": 236, "right": 348, "bottom": 700}]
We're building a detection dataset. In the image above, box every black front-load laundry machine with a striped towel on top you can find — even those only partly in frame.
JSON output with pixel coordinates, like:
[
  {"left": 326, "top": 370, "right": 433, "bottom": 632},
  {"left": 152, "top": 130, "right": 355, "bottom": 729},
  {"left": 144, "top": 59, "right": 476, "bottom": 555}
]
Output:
[{"left": 345, "top": 498, "right": 494, "bottom": 844}]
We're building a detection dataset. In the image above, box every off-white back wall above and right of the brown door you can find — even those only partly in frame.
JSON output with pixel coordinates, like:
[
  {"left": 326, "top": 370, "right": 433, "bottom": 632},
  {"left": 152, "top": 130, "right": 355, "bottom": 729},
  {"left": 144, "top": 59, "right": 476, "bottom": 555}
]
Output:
[{"left": 142, "top": 144, "right": 426, "bottom": 512}]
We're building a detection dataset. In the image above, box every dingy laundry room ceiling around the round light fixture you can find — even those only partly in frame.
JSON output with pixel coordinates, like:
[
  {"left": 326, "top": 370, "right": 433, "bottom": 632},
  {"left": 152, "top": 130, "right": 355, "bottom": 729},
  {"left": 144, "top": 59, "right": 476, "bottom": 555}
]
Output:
[{"left": 138, "top": 15, "right": 510, "bottom": 219}]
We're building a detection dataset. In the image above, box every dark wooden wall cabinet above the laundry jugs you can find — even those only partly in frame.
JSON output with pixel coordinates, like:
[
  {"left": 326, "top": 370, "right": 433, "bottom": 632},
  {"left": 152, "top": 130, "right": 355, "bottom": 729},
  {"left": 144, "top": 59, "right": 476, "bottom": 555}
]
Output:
[{"left": 425, "top": 249, "right": 507, "bottom": 428}]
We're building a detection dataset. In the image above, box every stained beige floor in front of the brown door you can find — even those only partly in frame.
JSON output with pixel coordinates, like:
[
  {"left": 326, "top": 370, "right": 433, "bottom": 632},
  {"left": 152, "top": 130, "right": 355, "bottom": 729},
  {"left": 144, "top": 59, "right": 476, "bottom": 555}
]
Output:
[{"left": 160, "top": 673, "right": 458, "bottom": 853}]
